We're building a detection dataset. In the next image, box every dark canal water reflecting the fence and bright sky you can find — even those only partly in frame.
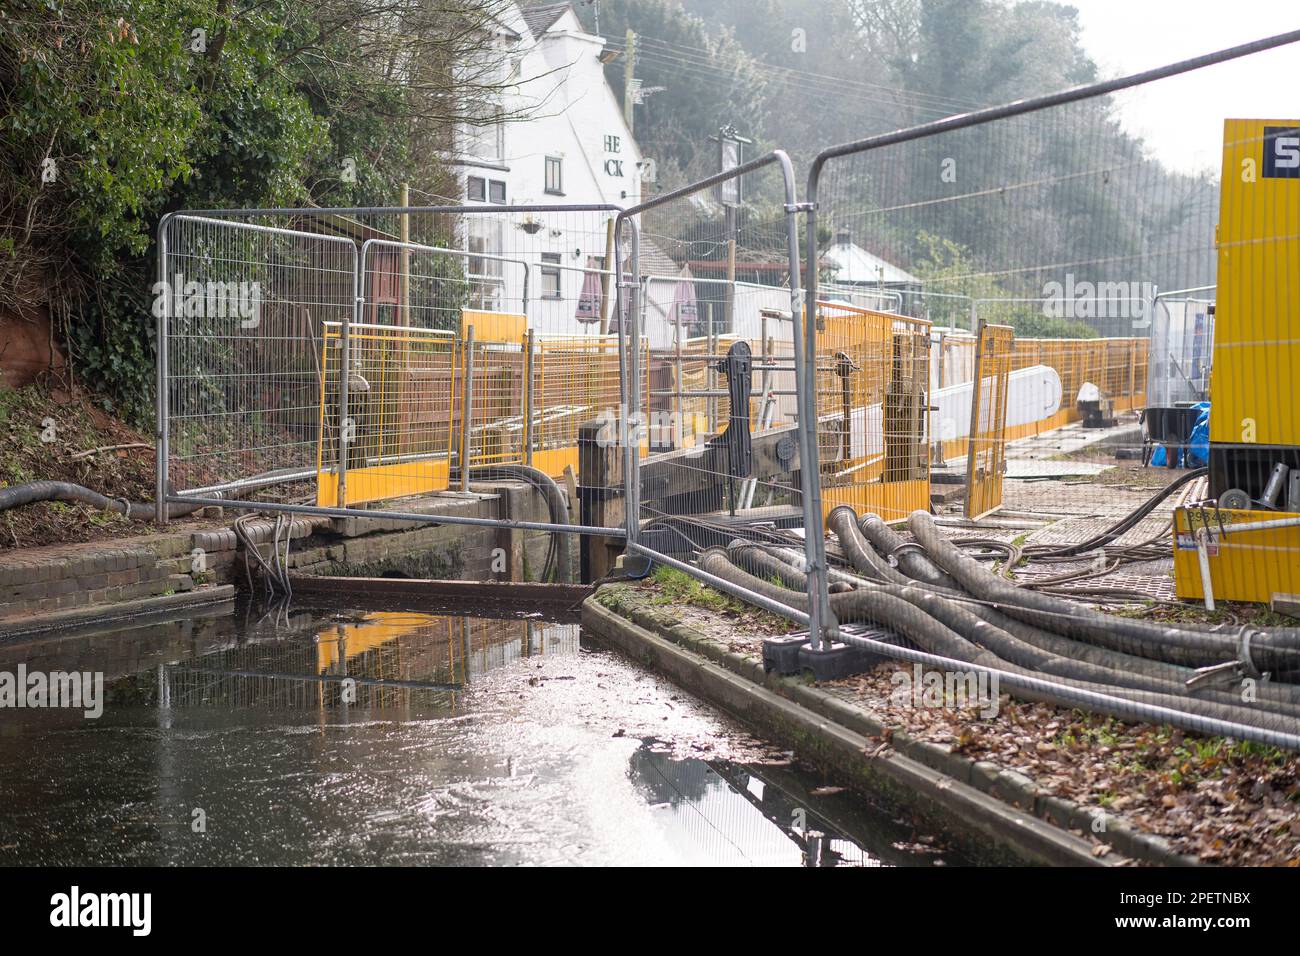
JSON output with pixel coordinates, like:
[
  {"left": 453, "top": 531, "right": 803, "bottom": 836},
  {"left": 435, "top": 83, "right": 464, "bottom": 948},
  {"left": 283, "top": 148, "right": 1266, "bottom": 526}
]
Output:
[{"left": 0, "top": 604, "right": 963, "bottom": 866}]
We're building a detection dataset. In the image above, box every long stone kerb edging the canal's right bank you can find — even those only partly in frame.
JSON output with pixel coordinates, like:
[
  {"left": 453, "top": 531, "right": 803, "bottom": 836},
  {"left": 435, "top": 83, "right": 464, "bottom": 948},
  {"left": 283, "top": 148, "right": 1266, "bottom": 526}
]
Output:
[{"left": 582, "top": 585, "right": 1200, "bottom": 866}]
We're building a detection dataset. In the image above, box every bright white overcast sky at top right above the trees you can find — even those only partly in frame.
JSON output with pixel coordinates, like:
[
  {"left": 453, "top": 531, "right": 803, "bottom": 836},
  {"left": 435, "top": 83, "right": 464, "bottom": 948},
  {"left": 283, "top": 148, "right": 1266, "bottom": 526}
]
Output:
[{"left": 1063, "top": 0, "right": 1300, "bottom": 172}]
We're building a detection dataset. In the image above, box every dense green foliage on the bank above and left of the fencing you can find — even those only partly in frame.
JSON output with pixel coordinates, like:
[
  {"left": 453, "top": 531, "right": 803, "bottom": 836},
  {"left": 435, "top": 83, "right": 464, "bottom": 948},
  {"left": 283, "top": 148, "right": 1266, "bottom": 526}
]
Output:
[{"left": 0, "top": 0, "right": 470, "bottom": 424}]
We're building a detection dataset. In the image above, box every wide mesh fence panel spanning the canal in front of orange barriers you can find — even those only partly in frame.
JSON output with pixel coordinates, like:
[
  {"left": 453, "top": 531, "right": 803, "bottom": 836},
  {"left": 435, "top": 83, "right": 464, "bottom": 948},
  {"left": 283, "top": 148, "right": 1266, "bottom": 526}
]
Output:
[{"left": 156, "top": 206, "right": 623, "bottom": 546}]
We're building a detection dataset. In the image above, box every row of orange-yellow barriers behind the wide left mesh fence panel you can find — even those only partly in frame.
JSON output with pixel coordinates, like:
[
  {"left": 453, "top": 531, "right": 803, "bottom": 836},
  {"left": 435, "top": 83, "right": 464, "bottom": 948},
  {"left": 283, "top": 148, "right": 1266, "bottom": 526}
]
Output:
[{"left": 317, "top": 311, "right": 650, "bottom": 506}]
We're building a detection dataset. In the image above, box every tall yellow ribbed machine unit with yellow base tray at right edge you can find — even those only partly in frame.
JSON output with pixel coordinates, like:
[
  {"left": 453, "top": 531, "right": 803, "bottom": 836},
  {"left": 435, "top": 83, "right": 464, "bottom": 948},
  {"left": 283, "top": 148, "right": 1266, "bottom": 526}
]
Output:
[{"left": 1174, "top": 120, "right": 1300, "bottom": 606}]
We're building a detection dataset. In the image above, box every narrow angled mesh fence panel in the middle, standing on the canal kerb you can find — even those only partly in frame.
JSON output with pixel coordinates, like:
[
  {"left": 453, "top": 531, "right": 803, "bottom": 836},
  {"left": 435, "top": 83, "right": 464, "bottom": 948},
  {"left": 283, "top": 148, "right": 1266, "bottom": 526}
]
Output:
[{"left": 618, "top": 153, "right": 820, "bottom": 632}]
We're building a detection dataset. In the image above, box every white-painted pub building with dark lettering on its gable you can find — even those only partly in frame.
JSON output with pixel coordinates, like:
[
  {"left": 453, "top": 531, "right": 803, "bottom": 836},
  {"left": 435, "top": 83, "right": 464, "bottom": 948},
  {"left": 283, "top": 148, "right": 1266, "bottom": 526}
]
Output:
[{"left": 458, "top": 3, "right": 642, "bottom": 334}]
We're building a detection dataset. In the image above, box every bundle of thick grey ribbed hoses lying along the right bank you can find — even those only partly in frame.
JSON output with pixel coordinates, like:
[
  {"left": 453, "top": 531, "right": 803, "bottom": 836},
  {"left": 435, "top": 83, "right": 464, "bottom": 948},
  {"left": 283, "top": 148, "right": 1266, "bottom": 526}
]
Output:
[{"left": 699, "top": 507, "right": 1300, "bottom": 739}]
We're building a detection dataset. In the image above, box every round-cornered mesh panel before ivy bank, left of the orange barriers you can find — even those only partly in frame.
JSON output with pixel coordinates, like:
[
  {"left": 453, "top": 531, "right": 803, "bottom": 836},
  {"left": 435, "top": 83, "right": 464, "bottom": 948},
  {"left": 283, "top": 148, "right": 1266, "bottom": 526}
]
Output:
[{"left": 155, "top": 216, "right": 358, "bottom": 502}]
